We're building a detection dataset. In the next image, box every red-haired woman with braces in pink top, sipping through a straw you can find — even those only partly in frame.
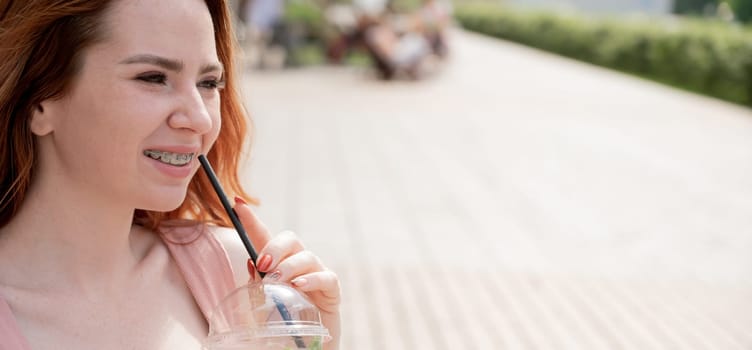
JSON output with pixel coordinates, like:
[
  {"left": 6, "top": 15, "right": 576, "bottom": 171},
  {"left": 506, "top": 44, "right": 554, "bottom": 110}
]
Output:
[{"left": 0, "top": 0, "right": 340, "bottom": 349}]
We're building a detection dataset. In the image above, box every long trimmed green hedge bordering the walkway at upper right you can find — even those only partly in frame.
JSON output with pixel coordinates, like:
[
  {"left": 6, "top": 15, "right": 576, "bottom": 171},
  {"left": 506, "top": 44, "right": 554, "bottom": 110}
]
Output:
[{"left": 455, "top": 3, "right": 752, "bottom": 106}]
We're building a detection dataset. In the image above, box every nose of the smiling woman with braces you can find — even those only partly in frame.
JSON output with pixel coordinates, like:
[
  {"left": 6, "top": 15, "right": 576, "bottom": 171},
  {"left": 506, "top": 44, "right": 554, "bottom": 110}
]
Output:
[{"left": 167, "top": 88, "right": 214, "bottom": 134}]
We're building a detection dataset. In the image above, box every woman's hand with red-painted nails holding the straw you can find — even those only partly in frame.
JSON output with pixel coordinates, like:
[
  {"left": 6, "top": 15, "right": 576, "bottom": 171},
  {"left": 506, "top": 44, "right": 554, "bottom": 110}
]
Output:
[{"left": 234, "top": 197, "right": 340, "bottom": 350}]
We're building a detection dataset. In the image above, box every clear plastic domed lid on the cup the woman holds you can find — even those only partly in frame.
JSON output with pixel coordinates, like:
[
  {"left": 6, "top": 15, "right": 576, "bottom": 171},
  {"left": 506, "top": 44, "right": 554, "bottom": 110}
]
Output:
[{"left": 204, "top": 282, "right": 329, "bottom": 350}]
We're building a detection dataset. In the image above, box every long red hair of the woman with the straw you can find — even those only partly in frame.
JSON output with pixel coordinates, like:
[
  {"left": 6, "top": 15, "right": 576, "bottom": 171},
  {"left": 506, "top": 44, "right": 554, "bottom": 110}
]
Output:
[{"left": 0, "top": 0, "right": 251, "bottom": 230}]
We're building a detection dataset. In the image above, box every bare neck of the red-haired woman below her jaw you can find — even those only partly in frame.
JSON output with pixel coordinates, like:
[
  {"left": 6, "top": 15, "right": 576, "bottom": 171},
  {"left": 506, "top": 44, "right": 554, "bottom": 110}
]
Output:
[{"left": 0, "top": 175, "right": 148, "bottom": 294}]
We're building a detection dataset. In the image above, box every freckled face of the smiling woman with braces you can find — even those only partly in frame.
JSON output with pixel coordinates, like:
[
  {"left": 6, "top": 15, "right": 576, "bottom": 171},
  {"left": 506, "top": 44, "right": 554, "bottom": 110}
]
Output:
[{"left": 42, "top": 0, "right": 223, "bottom": 211}]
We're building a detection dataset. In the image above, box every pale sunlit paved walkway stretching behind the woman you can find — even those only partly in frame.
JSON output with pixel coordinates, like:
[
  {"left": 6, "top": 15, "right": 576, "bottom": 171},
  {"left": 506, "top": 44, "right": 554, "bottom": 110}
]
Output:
[{"left": 238, "top": 28, "right": 752, "bottom": 350}]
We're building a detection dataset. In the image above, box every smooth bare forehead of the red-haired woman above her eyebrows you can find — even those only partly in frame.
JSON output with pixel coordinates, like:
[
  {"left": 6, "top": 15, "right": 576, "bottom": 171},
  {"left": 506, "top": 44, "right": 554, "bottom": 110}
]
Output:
[{"left": 95, "top": 0, "right": 217, "bottom": 61}]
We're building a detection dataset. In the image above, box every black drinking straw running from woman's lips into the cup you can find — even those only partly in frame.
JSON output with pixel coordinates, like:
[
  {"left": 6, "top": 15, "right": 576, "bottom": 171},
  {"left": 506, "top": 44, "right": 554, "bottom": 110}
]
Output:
[{"left": 198, "top": 154, "right": 306, "bottom": 349}]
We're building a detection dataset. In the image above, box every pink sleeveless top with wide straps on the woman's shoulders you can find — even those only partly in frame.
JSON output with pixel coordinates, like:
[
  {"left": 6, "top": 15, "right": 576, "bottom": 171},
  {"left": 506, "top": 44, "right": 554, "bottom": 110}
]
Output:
[{"left": 0, "top": 222, "right": 235, "bottom": 350}]
